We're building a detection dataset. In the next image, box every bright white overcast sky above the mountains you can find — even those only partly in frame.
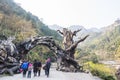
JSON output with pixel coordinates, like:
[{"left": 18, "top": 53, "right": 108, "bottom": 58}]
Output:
[{"left": 14, "top": 0, "right": 120, "bottom": 29}]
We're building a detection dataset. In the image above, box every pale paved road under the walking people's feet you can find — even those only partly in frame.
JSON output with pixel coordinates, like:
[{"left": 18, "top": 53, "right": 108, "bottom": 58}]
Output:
[{"left": 0, "top": 68, "right": 96, "bottom": 80}]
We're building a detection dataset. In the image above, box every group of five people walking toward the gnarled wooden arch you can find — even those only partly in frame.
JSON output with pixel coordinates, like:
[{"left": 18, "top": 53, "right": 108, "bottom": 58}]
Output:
[{"left": 20, "top": 58, "right": 51, "bottom": 78}]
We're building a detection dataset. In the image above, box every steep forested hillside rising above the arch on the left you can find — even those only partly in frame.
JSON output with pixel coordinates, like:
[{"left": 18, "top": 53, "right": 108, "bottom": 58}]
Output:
[{"left": 0, "top": 0, "right": 61, "bottom": 41}]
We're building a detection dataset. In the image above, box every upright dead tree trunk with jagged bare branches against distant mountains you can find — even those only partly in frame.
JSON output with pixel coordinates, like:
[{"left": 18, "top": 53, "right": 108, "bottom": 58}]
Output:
[{"left": 58, "top": 28, "right": 89, "bottom": 68}]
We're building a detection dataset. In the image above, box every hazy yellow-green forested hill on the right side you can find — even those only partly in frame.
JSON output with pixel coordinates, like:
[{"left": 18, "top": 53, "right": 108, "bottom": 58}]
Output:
[{"left": 80, "top": 19, "right": 120, "bottom": 59}]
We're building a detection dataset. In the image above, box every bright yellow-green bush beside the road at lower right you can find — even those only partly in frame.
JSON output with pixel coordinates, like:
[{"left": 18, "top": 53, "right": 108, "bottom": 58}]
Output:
[{"left": 86, "top": 62, "right": 116, "bottom": 80}]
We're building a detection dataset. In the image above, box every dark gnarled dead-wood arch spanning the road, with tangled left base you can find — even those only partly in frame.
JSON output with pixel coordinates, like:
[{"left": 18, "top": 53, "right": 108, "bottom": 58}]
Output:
[{"left": 0, "top": 36, "right": 87, "bottom": 75}]
